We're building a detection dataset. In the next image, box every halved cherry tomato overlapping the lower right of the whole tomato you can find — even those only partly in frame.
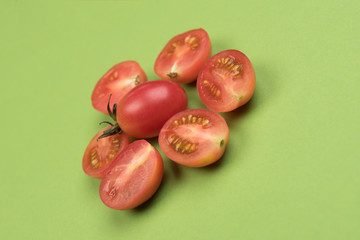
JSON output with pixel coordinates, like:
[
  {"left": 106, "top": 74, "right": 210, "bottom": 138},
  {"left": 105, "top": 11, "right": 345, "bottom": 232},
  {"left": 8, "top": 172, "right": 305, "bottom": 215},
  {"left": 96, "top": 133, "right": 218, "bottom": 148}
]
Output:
[{"left": 158, "top": 109, "right": 229, "bottom": 167}]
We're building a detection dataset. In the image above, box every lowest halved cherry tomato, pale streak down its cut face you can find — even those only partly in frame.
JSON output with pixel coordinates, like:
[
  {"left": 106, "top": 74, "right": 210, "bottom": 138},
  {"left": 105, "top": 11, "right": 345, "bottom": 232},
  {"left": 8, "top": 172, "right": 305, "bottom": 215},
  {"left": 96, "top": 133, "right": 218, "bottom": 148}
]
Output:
[{"left": 99, "top": 140, "right": 164, "bottom": 210}]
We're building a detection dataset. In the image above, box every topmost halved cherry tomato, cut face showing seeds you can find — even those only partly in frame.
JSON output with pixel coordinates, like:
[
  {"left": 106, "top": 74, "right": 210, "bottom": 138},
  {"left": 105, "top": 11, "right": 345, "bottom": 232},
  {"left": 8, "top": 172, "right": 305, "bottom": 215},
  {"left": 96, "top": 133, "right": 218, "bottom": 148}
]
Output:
[{"left": 154, "top": 28, "right": 211, "bottom": 83}]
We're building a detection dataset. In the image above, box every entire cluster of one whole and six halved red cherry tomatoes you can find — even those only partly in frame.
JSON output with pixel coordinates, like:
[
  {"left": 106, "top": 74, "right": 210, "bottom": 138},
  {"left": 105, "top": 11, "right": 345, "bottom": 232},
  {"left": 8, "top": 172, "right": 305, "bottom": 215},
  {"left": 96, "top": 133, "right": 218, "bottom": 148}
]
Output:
[{"left": 82, "top": 29, "right": 255, "bottom": 210}]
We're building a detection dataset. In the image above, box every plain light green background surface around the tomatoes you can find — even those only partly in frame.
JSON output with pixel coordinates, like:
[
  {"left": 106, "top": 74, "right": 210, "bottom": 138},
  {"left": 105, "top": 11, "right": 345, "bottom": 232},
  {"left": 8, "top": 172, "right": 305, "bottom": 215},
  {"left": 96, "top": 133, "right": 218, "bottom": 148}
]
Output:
[{"left": 0, "top": 0, "right": 360, "bottom": 240}]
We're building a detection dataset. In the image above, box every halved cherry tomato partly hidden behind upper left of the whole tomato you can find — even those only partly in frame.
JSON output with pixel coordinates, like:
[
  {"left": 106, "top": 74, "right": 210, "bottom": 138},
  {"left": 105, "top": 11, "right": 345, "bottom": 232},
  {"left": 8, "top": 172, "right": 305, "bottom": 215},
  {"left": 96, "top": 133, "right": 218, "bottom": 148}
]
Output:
[{"left": 91, "top": 61, "right": 147, "bottom": 114}]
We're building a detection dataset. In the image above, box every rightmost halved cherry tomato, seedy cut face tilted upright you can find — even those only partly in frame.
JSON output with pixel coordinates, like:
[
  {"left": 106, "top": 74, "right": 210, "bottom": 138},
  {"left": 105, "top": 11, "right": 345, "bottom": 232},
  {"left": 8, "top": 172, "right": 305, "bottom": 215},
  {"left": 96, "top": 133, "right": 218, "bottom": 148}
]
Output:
[{"left": 197, "top": 50, "right": 255, "bottom": 112}]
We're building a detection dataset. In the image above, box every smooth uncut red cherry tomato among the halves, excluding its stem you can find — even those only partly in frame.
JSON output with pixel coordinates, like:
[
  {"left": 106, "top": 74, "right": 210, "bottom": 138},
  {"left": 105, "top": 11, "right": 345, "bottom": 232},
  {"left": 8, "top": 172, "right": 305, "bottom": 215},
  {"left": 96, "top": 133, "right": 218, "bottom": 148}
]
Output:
[{"left": 116, "top": 80, "right": 188, "bottom": 138}]
